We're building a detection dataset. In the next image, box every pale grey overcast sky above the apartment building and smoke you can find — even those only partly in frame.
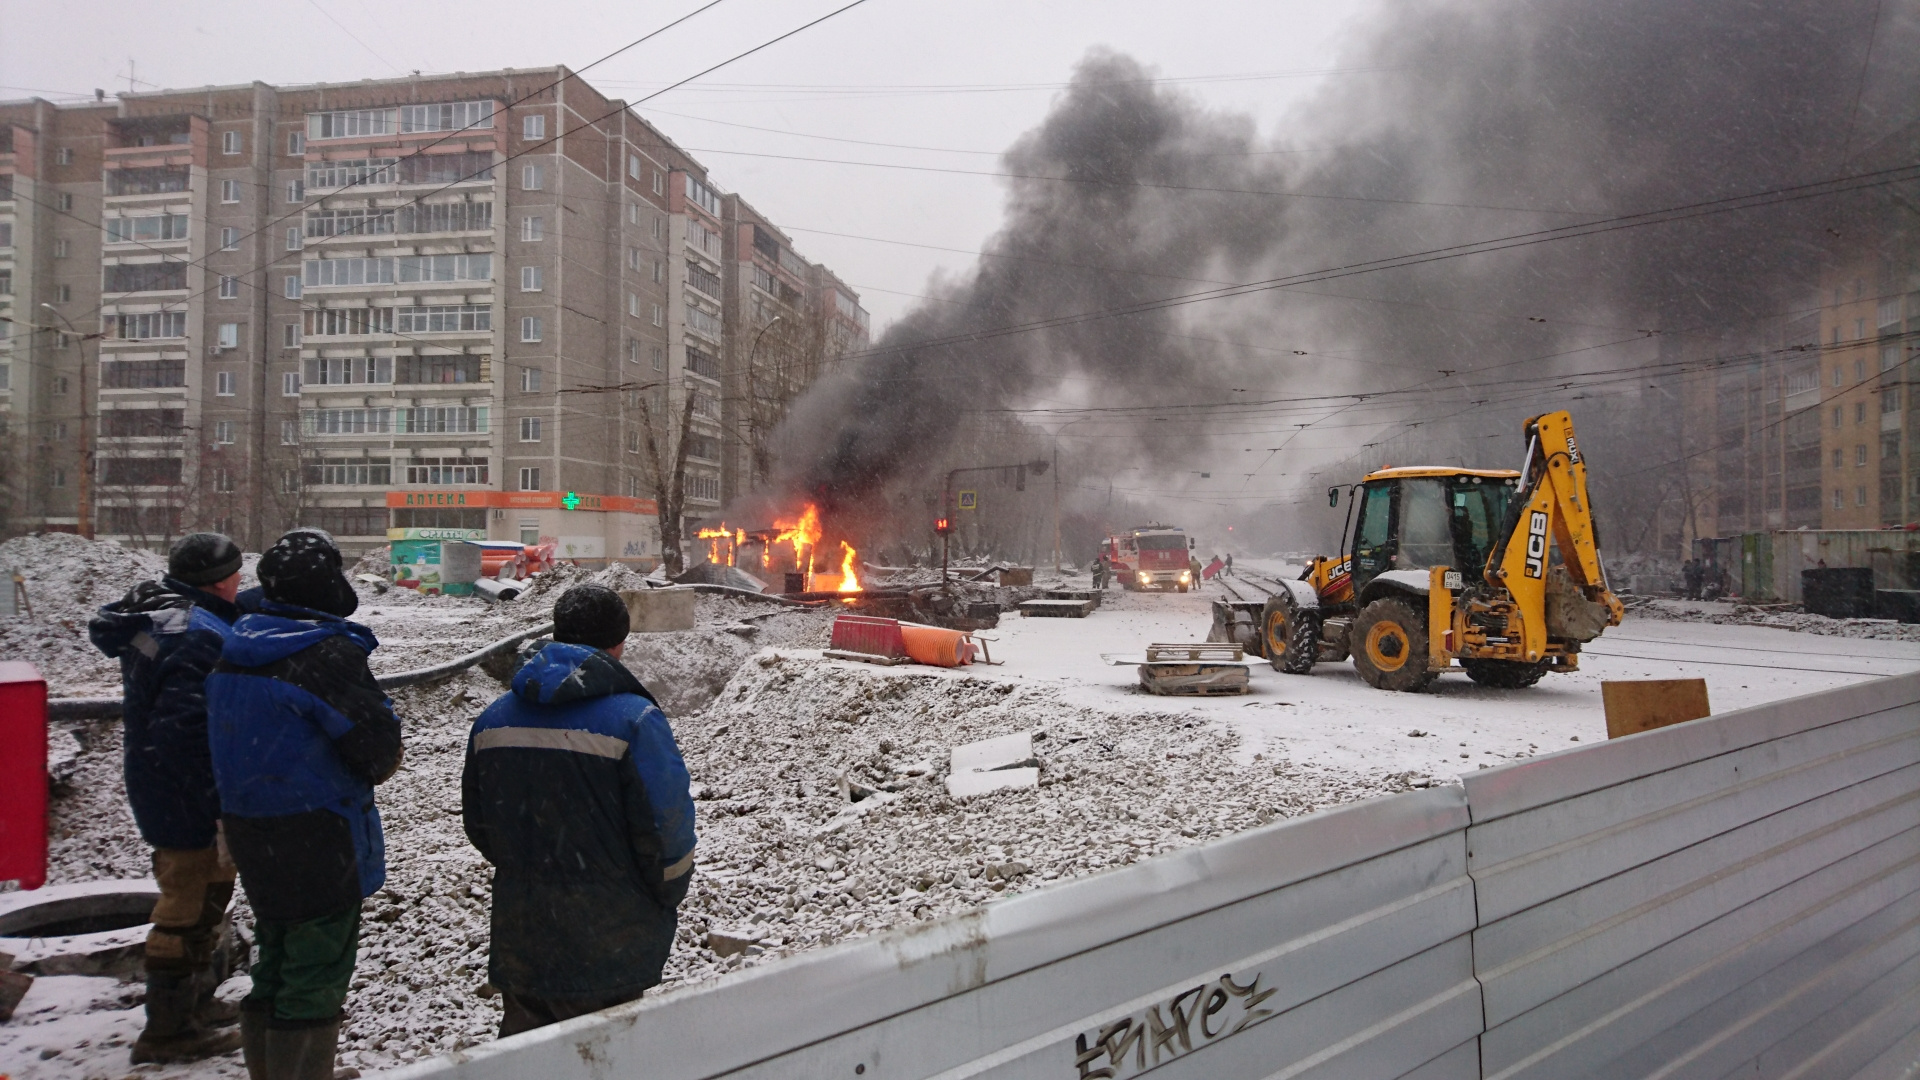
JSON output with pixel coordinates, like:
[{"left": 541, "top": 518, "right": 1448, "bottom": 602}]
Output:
[{"left": 0, "top": 0, "right": 1373, "bottom": 331}]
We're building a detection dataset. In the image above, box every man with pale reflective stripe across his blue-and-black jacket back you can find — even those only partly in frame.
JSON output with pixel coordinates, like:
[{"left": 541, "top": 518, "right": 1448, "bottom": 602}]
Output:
[{"left": 461, "top": 586, "right": 693, "bottom": 1036}]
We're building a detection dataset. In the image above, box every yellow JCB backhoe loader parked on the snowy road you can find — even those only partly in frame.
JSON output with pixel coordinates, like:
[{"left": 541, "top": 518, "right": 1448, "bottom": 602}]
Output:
[{"left": 1260, "top": 411, "right": 1624, "bottom": 690}]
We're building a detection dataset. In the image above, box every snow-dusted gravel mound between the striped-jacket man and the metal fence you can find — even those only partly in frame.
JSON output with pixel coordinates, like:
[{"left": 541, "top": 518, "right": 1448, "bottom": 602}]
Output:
[{"left": 668, "top": 651, "right": 1413, "bottom": 980}]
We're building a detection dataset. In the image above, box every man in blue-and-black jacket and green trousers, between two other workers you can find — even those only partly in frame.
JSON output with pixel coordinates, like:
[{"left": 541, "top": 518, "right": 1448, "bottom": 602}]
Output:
[{"left": 207, "top": 528, "right": 401, "bottom": 1080}]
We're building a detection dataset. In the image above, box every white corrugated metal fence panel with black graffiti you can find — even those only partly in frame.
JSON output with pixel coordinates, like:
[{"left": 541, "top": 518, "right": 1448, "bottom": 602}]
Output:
[{"left": 385, "top": 788, "right": 1480, "bottom": 1080}]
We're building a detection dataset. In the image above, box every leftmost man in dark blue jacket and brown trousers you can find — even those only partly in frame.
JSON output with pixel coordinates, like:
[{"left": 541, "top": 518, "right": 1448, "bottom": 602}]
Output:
[{"left": 86, "top": 532, "right": 240, "bottom": 1065}]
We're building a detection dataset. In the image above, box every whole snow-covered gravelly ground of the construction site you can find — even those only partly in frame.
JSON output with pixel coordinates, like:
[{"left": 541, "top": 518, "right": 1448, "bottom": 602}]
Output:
[{"left": 0, "top": 540, "right": 1920, "bottom": 1080}]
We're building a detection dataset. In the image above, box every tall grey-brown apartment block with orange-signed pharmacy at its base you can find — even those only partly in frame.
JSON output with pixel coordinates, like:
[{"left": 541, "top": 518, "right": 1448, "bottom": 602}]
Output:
[{"left": 0, "top": 67, "right": 864, "bottom": 561}]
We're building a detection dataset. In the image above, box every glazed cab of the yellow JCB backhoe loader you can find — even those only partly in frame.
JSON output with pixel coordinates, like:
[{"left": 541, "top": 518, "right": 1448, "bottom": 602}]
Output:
[{"left": 1348, "top": 467, "right": 1521, "bottom": 598}]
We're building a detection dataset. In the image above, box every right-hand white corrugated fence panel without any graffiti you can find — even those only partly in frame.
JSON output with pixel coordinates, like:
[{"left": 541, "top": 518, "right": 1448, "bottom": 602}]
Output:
[{"left": 1465, "top": 676, "right": 1920, "bottom": 1080}]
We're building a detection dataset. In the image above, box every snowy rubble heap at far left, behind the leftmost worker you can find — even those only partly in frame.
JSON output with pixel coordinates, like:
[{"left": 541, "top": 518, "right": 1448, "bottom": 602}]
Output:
[{"left": 0, "top": 532, "right": 167, "bottom": 696}]
